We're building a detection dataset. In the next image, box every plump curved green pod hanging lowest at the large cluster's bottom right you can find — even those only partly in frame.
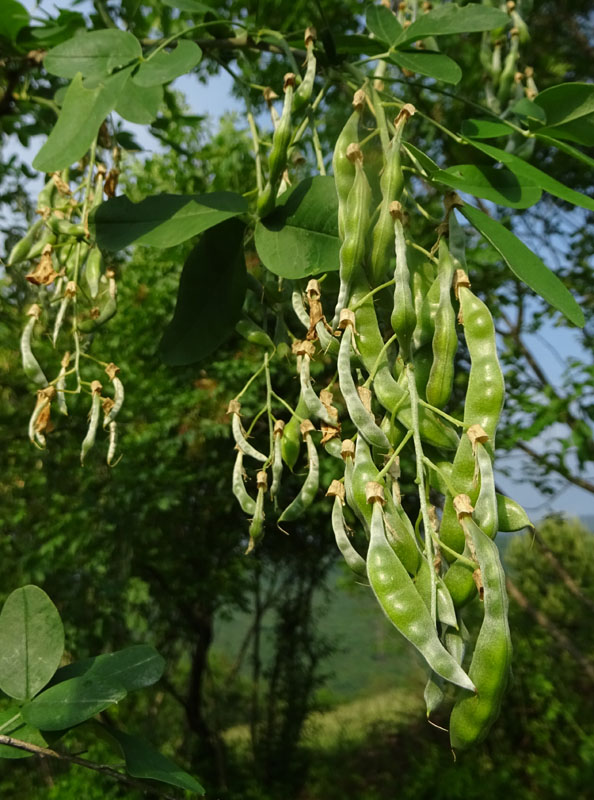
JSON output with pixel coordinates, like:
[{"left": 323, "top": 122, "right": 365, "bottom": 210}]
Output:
[{"left": 450, "top": 514, "right": 512, "bottom": 750}]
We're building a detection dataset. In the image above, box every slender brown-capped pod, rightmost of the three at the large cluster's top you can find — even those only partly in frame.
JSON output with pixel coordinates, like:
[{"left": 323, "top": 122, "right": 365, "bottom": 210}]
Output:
[{"left": 369, "top": 103, "right": 415, "bottom": 286}]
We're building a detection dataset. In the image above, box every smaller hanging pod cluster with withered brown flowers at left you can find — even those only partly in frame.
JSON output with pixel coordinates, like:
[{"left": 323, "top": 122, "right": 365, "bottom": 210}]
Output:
[{"left": 7, "top": 153, "right": 124, "bottom": 465}]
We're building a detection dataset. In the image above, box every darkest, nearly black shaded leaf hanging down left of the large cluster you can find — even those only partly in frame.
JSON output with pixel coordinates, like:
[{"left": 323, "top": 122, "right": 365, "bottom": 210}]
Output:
[{"left": 160, "top": 219, "right": 247, "bottom": 366}]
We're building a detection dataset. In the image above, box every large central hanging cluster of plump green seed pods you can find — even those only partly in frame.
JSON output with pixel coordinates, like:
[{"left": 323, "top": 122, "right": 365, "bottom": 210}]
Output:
[{"left": 228, "top": 84, "right": 529, "bottom": 749}]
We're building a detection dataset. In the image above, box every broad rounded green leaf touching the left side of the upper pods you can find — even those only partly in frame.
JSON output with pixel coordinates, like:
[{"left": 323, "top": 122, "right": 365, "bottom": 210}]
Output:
[{"left": 255, "top": 176, "right": 340, "bottom": 279}]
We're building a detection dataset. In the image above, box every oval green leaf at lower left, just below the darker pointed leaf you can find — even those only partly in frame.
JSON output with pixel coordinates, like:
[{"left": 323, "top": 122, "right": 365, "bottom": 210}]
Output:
[{"left": 21, "top": 675, "right": 126, "bottom": 731}]
